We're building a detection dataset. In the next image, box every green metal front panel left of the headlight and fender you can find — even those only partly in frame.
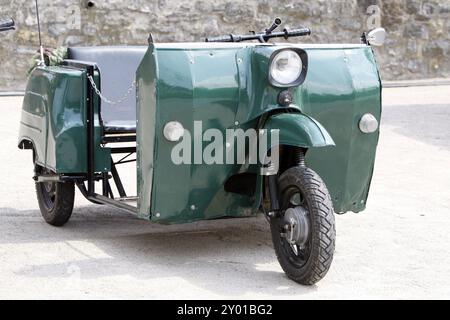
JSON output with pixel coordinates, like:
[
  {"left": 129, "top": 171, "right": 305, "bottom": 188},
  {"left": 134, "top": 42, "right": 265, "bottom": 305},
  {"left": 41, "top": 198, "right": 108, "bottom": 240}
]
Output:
[{"left": 138, "top": 48, "right": 253, "bottom": 223}]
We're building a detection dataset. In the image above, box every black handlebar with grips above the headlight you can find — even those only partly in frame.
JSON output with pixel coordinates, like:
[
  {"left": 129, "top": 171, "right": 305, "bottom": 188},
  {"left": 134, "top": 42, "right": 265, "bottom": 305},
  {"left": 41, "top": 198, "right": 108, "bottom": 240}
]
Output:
[{"left": 205, "top": 28, "right": 311, "bottom": 42}]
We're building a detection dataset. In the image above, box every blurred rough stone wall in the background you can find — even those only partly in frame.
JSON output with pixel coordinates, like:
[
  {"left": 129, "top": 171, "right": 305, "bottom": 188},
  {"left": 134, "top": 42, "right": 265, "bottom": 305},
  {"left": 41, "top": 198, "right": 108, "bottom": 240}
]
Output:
[{"left": 0, "top": 0, "right": 450, "bottom": 90}]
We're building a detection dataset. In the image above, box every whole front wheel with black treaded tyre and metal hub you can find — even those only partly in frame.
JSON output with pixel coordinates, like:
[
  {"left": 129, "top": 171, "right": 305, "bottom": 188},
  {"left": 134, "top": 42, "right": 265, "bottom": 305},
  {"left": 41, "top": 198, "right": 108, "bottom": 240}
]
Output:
[{"left": 270, "top": 166, "right": 336, "bottom": 285}]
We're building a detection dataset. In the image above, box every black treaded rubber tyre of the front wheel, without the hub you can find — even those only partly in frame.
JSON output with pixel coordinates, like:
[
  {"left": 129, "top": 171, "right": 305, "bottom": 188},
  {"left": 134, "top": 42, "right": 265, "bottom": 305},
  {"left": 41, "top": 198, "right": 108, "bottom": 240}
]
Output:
[{"left": 270, "top": 166, "right": 336, "bottom": 285}]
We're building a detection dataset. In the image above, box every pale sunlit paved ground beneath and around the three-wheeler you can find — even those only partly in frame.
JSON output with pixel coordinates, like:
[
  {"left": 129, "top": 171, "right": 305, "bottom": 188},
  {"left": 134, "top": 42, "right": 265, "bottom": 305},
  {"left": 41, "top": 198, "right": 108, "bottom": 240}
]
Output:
[{"left": 0, "top": 86, "right": 450, "bottom": 299}]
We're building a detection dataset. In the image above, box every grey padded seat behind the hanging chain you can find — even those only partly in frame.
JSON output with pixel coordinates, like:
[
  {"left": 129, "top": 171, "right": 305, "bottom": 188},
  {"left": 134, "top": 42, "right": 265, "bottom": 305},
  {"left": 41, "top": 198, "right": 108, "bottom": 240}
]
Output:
[{"left": 68, "top": 46, "right": 147, "bottom": 134}]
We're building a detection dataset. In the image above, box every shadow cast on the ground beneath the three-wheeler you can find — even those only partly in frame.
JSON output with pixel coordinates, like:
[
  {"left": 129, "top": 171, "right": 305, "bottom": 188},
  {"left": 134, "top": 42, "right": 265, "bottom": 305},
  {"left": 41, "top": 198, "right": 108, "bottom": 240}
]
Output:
[{"left": 0, "top": 206, "right": 315, "bottom": 296}]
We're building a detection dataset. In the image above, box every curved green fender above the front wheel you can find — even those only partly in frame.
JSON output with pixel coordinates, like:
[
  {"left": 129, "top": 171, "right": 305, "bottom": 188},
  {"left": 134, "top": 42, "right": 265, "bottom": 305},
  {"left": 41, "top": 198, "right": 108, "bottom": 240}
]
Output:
[{"left": 264, "top": 112, "right": 335, "bottom": 148}]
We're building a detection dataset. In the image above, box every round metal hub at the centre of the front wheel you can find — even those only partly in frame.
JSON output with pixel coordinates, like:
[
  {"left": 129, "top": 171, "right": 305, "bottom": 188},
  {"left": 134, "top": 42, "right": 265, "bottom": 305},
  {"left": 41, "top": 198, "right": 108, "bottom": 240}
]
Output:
[{"left": 284, "top": 206, "right": 310, "bottom": 247}]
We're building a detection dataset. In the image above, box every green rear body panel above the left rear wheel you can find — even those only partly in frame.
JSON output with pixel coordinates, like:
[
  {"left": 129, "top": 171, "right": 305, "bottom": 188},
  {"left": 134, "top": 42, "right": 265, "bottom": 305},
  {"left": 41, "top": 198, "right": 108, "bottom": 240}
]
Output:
[{"left": 19, "top": 67, "right": 110, "bottom": 174}]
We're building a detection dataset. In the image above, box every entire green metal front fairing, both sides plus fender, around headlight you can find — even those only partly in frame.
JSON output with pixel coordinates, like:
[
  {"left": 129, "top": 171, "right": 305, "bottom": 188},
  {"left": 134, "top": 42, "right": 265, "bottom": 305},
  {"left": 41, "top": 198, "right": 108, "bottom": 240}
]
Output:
[{"left": 137, "top": 45, "right": 381, "bottom": 223}]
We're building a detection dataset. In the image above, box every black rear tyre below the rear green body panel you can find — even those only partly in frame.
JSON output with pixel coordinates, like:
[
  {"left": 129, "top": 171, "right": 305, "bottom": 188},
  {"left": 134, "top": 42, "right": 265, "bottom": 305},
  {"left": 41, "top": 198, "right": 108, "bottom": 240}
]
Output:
[{"left": 36, "top": 174, "right": 75, "bottom": 227}]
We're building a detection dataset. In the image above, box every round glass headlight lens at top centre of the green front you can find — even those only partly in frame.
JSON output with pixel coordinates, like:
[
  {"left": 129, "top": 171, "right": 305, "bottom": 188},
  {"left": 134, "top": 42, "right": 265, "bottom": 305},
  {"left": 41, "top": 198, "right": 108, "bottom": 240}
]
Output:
[{"left": 270, "top": 50, "right": 303, "bottom": 86}]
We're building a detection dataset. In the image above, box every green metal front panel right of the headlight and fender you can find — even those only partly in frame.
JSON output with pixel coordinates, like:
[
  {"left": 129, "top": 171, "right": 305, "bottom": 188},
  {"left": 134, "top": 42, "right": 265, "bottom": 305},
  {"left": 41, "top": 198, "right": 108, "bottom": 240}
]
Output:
[{"left": 295, "top": 47, "right": 381, "bottom": 212}]
